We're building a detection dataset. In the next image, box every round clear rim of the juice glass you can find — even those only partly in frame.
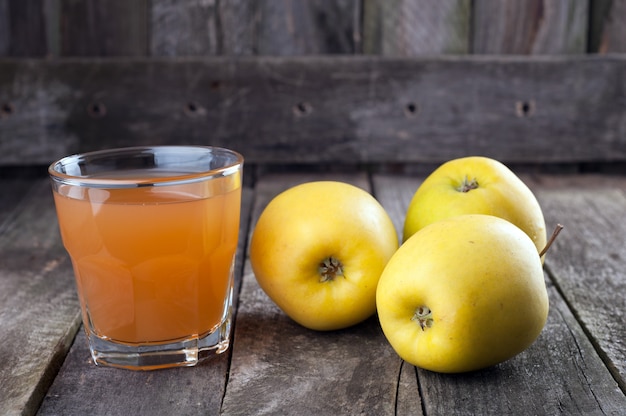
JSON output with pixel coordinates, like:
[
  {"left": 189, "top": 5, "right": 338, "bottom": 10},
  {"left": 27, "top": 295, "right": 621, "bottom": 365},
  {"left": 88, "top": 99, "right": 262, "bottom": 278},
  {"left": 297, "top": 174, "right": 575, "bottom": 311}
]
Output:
[{"left": 48, "top": 145, "right": 244, "bottom": 189}]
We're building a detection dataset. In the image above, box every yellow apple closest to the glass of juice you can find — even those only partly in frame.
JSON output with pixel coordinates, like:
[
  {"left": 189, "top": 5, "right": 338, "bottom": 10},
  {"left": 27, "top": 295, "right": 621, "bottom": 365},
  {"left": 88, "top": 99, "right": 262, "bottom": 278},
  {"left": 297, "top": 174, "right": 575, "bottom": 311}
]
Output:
[{"left": 250, "top": 181, "right": 398, "bottom": 330}]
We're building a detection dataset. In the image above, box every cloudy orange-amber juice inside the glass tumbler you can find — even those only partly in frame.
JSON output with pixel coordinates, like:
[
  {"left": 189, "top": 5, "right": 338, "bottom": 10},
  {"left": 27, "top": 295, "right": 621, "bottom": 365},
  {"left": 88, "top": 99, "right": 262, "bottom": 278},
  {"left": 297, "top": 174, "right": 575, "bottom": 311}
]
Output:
[{"left": 54, "top": 179, "right": 241, "bottom": 344}]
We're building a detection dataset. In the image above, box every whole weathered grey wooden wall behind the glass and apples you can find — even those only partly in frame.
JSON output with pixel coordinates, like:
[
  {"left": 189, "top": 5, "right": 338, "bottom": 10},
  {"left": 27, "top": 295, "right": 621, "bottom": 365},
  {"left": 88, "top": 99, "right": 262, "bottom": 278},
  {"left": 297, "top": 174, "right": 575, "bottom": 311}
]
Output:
[{"left": 0, "top": 0, "right": 626, "bottom": 172}]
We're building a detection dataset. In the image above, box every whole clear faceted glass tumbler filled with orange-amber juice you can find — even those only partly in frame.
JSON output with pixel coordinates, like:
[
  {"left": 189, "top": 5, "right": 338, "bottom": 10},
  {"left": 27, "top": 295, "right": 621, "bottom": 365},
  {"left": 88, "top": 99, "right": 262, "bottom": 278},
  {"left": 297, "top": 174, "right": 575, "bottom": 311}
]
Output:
[{"left": 48, "top": 146, "right": 243, "bottom": 370}]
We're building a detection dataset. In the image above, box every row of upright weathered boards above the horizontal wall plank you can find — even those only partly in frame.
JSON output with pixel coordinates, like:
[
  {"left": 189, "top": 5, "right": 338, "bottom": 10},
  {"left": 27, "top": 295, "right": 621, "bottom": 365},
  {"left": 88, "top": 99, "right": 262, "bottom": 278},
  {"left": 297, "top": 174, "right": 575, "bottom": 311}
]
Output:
[{"left": 0, "top": 0, "right": 626, "bottom": 57}]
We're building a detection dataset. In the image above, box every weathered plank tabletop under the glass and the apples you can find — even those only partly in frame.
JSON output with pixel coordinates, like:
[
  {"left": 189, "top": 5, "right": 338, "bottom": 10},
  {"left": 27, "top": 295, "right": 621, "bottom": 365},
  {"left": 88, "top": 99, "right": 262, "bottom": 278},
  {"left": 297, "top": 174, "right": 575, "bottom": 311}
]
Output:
[{"left": 0, "top": 173, "right": 626, "bottom": 415}]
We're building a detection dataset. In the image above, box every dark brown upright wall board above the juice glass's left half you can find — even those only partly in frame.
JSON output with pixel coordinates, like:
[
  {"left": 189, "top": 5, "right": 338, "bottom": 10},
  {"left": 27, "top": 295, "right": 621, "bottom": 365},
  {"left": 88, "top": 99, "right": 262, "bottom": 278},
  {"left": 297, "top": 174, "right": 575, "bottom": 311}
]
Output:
[{"left": 58, "top": 0, "right": 149, "bottom": 56}]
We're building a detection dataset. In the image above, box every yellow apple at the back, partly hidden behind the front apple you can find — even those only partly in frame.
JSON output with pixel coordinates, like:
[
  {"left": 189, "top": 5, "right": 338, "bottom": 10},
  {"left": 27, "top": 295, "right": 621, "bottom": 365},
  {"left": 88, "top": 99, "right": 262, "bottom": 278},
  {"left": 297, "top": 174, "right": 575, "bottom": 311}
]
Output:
[{"left": 403, "top": 156, "right": 547, "bottom": 258}]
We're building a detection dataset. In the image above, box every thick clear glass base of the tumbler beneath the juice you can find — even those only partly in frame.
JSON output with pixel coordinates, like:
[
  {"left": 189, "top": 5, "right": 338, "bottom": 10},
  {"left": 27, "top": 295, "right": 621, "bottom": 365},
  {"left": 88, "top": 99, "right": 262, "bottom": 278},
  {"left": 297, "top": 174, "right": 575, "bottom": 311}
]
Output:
[{"left": 85, "top": 314, "right": 231, "bottom": 370}]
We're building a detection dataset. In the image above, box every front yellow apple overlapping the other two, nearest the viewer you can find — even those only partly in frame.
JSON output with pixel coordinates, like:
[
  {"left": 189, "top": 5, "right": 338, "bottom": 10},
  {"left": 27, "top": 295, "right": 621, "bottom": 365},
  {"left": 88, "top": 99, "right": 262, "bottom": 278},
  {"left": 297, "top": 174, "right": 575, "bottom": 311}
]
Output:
[{"left": 376, "top": 215, "right": 548, "bottom": 373}]
